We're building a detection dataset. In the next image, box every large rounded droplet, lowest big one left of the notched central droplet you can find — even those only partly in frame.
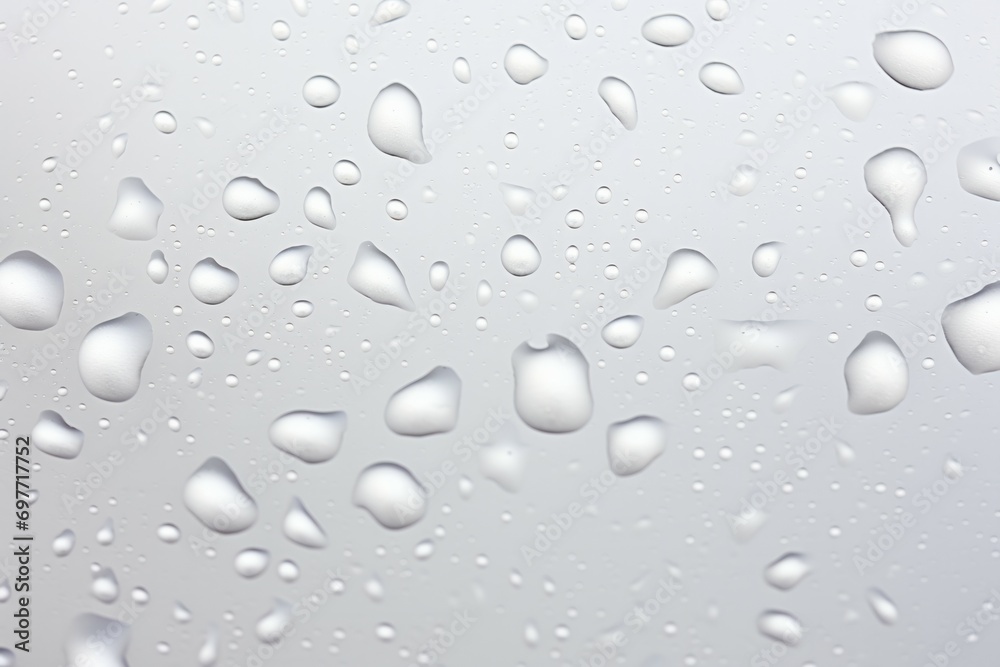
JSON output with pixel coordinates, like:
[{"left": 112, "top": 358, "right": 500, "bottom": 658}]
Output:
[{"left": 354, "top": 463, "right": 427, "bottom": 529}]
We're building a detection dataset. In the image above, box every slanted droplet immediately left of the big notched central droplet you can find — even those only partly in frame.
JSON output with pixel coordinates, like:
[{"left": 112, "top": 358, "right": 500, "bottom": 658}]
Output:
[{"left": 385, "top": 366, "right": 462, "bottom": 436}]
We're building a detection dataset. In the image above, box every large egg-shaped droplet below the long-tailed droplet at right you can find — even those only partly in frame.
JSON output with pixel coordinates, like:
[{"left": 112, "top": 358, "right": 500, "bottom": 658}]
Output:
[{"left": 844, "top": 331, "right": 910, "bottom": 415}]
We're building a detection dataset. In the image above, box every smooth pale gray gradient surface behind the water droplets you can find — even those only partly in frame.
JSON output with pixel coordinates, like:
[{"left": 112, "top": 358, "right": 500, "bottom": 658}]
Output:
[{"left": 0, "top": 0, "right": 1000, "bottom": 666}]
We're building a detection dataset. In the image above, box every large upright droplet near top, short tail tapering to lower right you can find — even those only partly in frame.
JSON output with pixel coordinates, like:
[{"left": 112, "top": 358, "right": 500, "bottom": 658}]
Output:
[{"left": 368, "top": 83, "right": 431, "bottom": 164}]
